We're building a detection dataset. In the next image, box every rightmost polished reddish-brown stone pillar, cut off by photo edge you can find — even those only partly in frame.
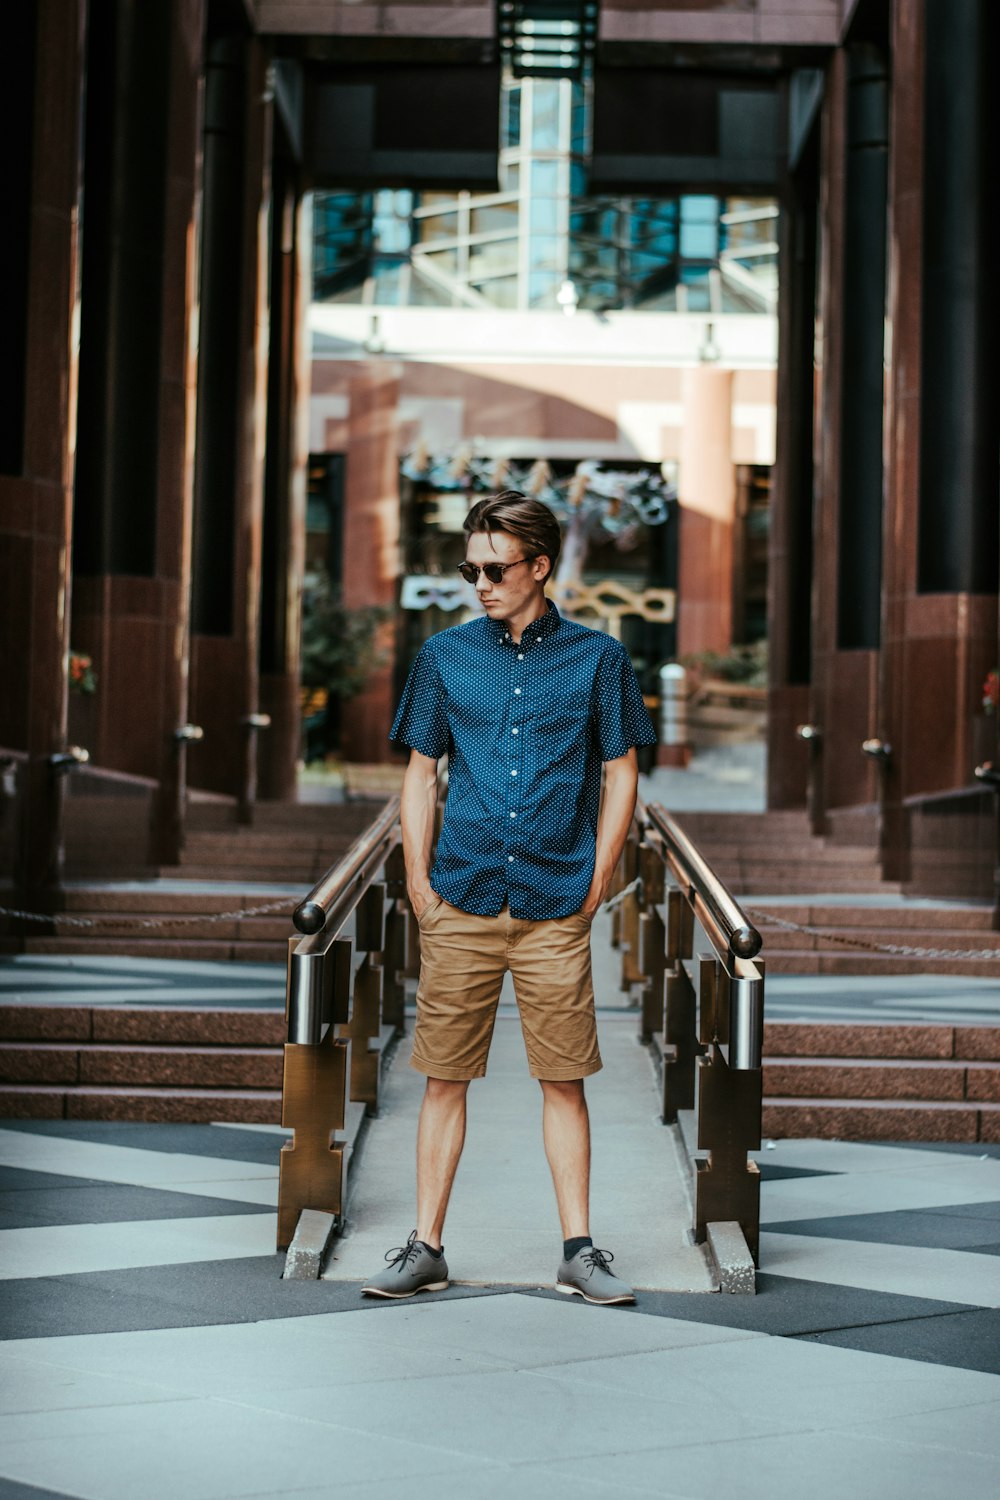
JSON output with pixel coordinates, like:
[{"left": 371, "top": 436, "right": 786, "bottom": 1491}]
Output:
[{"left": 879, "top": 0, "right": 999, "bottom": 879}]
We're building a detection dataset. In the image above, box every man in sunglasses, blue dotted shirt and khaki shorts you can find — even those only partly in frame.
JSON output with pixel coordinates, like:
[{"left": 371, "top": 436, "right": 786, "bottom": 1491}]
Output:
[{"left": 361, "top": 491, "right": 655, "bottom": 1304}]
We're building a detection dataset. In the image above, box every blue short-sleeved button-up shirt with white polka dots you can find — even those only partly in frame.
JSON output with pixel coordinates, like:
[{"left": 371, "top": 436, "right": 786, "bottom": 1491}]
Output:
[{"left": 390, "top": 603, "right": 657, "bottom": 921}]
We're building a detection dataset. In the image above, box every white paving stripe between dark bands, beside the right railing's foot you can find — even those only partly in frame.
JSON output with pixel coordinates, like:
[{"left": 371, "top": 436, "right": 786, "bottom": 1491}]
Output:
[{"left": 760, "top": 1233, "right": 1000, "bottom": 1308}]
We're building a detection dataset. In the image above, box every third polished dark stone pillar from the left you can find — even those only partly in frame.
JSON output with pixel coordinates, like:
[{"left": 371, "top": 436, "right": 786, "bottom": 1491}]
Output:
[{"left": 190, "top": 29, "right": 271, "bottom": 816}]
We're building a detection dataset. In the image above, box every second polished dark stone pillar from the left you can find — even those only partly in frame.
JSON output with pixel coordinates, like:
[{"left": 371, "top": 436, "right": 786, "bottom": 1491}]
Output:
[{"left": 73, "top": 0, "right": 204, "bottom": 861}]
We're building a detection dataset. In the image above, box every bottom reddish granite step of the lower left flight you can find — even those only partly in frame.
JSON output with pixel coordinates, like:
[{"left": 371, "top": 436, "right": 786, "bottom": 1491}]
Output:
[{"left": 0, "top": 1083, "right": 282, "bottom": 1125}]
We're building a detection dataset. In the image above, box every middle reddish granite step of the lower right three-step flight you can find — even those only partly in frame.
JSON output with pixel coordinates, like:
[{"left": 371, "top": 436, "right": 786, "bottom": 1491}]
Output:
[{"left": 763, "top": 1058, "right": 1000, "bottom": 1103}]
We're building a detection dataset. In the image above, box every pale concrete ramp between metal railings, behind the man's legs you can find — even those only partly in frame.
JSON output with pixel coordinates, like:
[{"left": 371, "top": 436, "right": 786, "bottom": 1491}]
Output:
[{"left": 324, "top": 1005, "right": 718, "bottom": 1292}]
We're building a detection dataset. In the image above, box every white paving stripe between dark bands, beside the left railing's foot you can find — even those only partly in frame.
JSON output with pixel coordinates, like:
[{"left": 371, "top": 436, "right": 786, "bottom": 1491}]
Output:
[{"left": 0, "top": 1214, "right": 277, "bottom": 1281}]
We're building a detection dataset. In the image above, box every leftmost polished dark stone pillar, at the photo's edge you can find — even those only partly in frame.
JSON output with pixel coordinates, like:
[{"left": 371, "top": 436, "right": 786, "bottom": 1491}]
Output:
[{"left": 0, "top": 0, "right": 85, "bottom": 909}]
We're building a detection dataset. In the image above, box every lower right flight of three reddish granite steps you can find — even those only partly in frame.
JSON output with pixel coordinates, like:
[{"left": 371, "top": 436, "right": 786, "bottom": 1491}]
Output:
[{"left": 763, "top": 1022, "right": 1000, "bottom": 1142}]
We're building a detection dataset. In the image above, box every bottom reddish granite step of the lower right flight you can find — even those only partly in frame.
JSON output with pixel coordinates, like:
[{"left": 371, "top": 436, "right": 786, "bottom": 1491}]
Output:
[{"left": 763, "top": 1098, "right": 1000, "bottom": 1142}]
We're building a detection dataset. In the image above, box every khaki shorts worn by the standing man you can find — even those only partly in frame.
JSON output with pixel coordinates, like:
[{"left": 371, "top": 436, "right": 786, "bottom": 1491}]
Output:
[{"left": 411, "top": 896, "right": 601, "bottom": 1082}]
